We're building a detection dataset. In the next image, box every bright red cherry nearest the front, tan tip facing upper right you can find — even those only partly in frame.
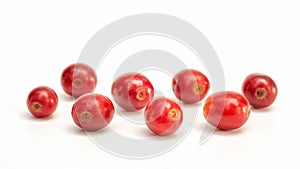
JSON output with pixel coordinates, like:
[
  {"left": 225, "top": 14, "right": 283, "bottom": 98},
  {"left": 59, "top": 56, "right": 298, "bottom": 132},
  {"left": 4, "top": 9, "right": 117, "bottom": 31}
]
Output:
[{"left": 144, "top": 97, "right": 183, "bottom": 136}]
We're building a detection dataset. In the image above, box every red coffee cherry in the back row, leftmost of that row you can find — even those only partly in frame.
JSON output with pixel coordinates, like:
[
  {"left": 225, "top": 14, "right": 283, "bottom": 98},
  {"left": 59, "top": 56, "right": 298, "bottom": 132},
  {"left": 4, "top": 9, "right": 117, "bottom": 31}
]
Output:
[{"left": 61, "top": 63, "right": 97, "bottom": 98}]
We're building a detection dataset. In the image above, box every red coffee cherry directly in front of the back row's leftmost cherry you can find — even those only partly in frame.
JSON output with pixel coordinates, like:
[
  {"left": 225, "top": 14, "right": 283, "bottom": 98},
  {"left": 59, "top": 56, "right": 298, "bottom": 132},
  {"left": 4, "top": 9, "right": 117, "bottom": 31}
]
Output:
[{"left": 72, "top": 93, "right": 115, "bottom": 131}]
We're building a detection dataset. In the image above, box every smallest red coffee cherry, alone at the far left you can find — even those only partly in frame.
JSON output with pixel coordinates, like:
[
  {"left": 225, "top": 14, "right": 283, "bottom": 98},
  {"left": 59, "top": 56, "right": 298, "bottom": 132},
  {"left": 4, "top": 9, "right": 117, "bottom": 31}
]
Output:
[{"left": 27, "top": 86, "right": 58, "bottom": 118}]
